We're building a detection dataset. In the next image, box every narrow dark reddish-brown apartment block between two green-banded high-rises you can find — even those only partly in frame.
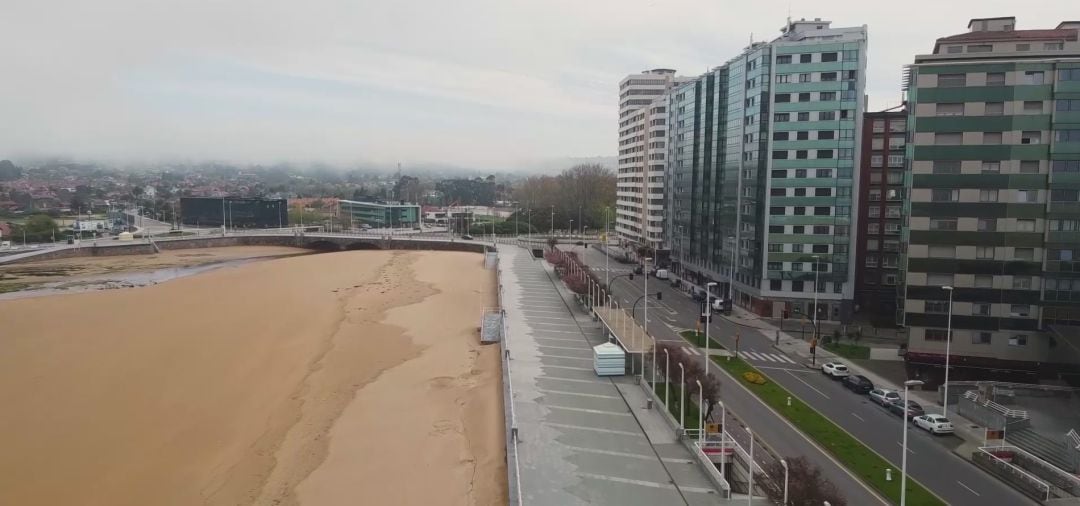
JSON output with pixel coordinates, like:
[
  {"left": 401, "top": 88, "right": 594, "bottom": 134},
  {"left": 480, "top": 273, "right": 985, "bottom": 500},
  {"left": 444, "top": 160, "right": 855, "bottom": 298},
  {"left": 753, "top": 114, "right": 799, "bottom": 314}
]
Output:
[{"left": 854, "top": 107, "right": 909, "bottom": 327}]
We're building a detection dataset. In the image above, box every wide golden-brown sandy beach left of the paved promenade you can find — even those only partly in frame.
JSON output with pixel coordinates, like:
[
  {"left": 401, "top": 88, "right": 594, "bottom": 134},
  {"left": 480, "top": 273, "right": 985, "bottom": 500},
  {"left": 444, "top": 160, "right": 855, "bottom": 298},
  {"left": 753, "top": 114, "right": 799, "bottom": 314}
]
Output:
[{"left": 0, "top": 250, "right": 505, "bottom": 505}]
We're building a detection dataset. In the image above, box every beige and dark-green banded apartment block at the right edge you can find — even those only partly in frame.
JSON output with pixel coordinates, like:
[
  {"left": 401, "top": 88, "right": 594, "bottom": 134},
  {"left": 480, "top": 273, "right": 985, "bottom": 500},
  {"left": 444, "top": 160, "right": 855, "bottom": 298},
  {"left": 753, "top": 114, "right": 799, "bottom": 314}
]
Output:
[{"left": 899, "top": 17, "right": 1080, "bottom": 381}]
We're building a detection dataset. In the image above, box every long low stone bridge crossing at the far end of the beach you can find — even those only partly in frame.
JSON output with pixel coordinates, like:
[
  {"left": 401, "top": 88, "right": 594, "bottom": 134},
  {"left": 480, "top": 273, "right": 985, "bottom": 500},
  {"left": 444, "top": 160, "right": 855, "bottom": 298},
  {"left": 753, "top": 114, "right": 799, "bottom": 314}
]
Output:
[{"left": 0, "top": 233, "right": 491, "bottom": 264}]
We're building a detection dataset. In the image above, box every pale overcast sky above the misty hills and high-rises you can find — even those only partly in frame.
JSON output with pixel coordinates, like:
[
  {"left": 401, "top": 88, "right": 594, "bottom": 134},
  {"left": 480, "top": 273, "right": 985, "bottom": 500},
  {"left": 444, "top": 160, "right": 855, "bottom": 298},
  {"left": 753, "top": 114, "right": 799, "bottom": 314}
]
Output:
[{"left": 0, "top": 0, "right": 1067, "bottom": 168}]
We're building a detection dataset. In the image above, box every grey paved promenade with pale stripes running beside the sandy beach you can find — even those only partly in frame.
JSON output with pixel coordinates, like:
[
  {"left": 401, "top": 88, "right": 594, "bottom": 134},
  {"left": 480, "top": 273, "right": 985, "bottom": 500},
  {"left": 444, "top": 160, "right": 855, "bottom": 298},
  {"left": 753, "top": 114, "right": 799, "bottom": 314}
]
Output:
[{"left": 498, "top": 245, "right": 720, "bottom": 506}]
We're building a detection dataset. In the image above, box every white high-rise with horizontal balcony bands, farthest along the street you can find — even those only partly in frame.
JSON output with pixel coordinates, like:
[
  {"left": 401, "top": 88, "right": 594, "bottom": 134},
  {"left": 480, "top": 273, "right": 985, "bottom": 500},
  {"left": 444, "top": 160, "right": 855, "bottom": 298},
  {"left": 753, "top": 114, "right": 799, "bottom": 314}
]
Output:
[{"left": 615, "top": 69, "right": 680, "bottom": 249}]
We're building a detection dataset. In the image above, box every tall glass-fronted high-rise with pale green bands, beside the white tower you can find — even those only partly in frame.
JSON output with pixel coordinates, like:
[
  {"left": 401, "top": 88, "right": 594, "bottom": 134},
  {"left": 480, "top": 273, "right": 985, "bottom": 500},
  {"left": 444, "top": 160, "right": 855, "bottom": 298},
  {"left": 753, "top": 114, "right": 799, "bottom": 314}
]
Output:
[{"left": 667, "top": 19, "right": 866, "bottom": 320}]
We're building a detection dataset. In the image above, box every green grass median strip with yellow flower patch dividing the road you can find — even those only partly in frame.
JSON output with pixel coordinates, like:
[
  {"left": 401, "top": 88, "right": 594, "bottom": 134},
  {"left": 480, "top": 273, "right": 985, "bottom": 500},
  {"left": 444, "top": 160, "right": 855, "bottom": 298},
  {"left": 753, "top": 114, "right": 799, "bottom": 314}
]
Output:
[{"left": 713, "top": 357, "right": 945, "bottom": 506}]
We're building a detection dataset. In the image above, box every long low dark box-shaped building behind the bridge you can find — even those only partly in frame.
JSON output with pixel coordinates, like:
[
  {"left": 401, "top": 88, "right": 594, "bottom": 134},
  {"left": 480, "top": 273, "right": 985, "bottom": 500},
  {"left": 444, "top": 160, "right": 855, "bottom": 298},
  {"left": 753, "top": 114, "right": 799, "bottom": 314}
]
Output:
[{"left": 180, "top": 196, "right": 288, "bottom": 229}]
